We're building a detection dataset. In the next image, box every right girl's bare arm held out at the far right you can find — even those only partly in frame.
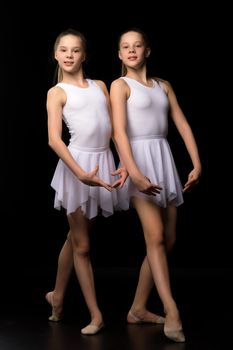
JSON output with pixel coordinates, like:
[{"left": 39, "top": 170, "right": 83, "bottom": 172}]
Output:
[{"left": 162, "top": 81, "right": 201, "bottom": 192}]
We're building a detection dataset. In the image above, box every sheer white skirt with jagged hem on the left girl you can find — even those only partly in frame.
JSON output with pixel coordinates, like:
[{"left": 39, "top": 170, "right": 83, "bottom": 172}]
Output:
[{"left": 51, "top": 145, "right": 124, "bottom": 219}]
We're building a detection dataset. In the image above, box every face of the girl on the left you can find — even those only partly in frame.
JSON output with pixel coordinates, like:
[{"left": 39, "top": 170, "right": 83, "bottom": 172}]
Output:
[{"left": 55, "top": 34, "right": 85, "bottom": 73}]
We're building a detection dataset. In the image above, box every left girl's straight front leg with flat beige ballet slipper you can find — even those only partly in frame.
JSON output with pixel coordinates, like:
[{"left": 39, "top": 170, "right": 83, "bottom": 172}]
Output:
[{"left": 68, "top": 209, "right": 103, "bottom": 334}]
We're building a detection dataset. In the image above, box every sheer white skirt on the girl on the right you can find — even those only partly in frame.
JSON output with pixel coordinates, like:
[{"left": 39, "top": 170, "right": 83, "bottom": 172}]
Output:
[{"left": 118, "top": 137, "right": 184, "bottom": 208}]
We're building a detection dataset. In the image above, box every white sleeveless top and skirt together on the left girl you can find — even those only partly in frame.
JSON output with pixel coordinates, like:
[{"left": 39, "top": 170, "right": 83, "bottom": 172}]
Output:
[{"left": 51, "top": 79, "right": 124, "bottom": 219}]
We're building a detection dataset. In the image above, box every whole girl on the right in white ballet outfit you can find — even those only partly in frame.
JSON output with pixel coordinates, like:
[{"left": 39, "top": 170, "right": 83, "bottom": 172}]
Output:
[{"left": 110, "top": 28, "right": 201, "bottom": 342}]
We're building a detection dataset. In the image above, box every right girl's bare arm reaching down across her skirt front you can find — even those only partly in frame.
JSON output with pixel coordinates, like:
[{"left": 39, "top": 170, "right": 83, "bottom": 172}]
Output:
[{"left": 110, "top": 79, "right": 161, "bottom": 196}]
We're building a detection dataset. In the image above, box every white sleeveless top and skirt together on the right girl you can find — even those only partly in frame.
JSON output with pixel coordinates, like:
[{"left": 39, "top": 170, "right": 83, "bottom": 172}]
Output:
[{"left": 119, "top": 77, "right": 183, "bottom": 207}]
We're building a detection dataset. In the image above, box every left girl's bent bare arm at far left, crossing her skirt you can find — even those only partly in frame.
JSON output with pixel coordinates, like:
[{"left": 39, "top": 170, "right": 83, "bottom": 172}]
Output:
[{"left": 46, "top": 87, "right": 112, "bottom": 191}]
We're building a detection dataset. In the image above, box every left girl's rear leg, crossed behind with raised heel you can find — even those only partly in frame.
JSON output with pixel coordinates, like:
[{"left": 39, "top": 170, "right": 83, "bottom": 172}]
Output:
[{"left": 46, "top": 232, "right": 73, "bottom": 321}]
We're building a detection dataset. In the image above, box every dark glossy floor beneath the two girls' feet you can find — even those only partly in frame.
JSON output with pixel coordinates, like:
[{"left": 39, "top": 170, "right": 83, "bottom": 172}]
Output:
[{"left": 0, "top": 267, "right": 233, "bottom": 350}]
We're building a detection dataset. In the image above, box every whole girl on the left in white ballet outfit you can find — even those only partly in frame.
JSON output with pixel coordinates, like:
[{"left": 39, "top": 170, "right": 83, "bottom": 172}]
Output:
[{"left": 46, "top": 29, "right": 127, "bottom": 334}]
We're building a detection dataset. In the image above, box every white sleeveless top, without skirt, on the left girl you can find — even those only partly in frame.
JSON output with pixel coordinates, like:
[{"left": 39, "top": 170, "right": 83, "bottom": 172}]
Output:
[{"left": 56, "top": 79, "right": 111, "bottom": 150}]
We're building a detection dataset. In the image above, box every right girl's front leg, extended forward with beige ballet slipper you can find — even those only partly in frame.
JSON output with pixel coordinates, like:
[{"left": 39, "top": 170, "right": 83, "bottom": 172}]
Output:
[{"left": 133, "top": 198, "right": 184, "bottom": 341}]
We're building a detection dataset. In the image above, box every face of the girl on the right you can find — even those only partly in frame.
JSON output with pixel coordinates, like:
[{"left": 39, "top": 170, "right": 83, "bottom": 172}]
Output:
[{"left": 118, "top": 31, "right": 149, "bottom": 69}]
